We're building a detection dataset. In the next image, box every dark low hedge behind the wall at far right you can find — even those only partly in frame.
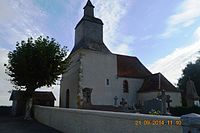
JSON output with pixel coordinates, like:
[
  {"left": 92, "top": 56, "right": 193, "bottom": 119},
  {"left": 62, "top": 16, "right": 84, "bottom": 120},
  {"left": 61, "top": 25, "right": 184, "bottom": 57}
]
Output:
[{"left": 170, "top": 106, "right": 200, "bottom": 116}]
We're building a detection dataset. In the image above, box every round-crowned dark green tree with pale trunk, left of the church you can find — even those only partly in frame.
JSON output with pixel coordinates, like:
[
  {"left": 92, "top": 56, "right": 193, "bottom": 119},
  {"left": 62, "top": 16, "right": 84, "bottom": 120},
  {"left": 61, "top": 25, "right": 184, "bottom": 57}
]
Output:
[{"left": 6, "top": 36, "right": 68, "bottom": 119}]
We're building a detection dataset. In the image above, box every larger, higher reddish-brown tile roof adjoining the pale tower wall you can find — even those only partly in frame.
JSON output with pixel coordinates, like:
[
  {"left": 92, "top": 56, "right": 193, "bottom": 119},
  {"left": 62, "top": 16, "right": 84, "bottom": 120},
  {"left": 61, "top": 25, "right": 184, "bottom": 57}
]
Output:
[{"left": 117, "top": 55, "right": 152, "bottom": 78}]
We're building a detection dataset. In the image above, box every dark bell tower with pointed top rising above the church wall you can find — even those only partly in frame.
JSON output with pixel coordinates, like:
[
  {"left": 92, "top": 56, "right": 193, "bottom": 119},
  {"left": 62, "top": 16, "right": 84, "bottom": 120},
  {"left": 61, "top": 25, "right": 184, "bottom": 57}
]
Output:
[{"left": 72, "top": 0, "right": 111, "bottom": 53}]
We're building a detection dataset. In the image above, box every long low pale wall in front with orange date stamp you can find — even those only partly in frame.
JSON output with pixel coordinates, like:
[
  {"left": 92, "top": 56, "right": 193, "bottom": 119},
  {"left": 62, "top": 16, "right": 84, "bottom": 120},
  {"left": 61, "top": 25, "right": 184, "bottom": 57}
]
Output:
[{"left": 34, "top": 106, "right": 182, "bottom": 133}]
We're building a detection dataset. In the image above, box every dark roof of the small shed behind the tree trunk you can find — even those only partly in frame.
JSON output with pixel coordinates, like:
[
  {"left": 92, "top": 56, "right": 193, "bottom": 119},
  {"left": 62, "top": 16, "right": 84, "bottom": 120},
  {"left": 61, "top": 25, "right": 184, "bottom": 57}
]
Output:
[{"left": 10, "top": 90, "right": 56, "bottom": 100}]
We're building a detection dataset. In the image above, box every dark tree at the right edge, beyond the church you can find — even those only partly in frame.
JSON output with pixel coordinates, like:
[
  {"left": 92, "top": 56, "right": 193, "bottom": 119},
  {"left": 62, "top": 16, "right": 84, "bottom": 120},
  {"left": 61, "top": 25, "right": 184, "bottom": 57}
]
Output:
[{"left": 177, "top": 58, "right": 200, "bottom": 106}]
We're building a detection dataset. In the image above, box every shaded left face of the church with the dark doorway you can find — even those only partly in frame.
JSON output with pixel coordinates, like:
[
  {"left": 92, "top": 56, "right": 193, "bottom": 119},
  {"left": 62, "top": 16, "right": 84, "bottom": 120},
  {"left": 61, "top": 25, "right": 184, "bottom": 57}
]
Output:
[{"left": 60, "top": 54, "right": 80, "bottom": 108}]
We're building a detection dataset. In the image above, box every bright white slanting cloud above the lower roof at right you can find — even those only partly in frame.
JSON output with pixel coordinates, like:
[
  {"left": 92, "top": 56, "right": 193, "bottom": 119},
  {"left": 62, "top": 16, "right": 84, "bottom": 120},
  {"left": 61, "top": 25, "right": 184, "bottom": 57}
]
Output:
[{"left": 149, "top": 27, "right": 200, "bottom": 83}]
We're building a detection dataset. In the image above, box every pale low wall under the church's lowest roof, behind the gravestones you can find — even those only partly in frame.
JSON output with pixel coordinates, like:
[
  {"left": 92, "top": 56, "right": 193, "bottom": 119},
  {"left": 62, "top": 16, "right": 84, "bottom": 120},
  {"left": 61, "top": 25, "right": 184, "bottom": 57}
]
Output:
[{"left": 138, "top": 91, "right": 182, "bottom": 107}]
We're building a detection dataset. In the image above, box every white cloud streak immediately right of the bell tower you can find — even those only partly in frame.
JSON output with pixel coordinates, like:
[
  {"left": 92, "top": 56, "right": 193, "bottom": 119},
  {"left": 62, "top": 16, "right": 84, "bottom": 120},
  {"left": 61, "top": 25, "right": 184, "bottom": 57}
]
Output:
[{"left": 94, "top": 0, "right": 134, "bottom": 54}]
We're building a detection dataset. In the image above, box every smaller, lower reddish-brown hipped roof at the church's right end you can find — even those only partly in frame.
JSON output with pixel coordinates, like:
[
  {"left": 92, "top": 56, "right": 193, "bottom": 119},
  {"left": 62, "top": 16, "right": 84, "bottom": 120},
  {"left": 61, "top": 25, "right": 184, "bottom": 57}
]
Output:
[{"left": 138, "top": 73, "right": 179, "bottom": 92}]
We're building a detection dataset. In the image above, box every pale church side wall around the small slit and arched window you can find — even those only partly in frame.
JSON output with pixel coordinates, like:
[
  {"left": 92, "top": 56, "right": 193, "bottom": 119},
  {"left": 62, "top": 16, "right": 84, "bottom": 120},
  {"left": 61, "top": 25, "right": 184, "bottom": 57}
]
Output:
[{"left": 81, "top": 50, "right": 143, "bottom": 105}]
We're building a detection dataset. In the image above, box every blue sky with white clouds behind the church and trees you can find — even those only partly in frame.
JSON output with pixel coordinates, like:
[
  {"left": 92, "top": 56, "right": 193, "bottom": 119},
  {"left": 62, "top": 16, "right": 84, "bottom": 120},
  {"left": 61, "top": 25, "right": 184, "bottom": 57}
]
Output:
[{"left": 0, "top": 0, "right": 200, "bottom": 105}]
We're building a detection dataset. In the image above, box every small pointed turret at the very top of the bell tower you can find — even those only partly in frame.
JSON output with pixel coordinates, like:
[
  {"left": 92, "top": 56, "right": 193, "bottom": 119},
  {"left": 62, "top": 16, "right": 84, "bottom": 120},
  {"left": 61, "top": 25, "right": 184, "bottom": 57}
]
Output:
[{"left": 83, "top": 0, "right": 94, "bottom": 17}]
